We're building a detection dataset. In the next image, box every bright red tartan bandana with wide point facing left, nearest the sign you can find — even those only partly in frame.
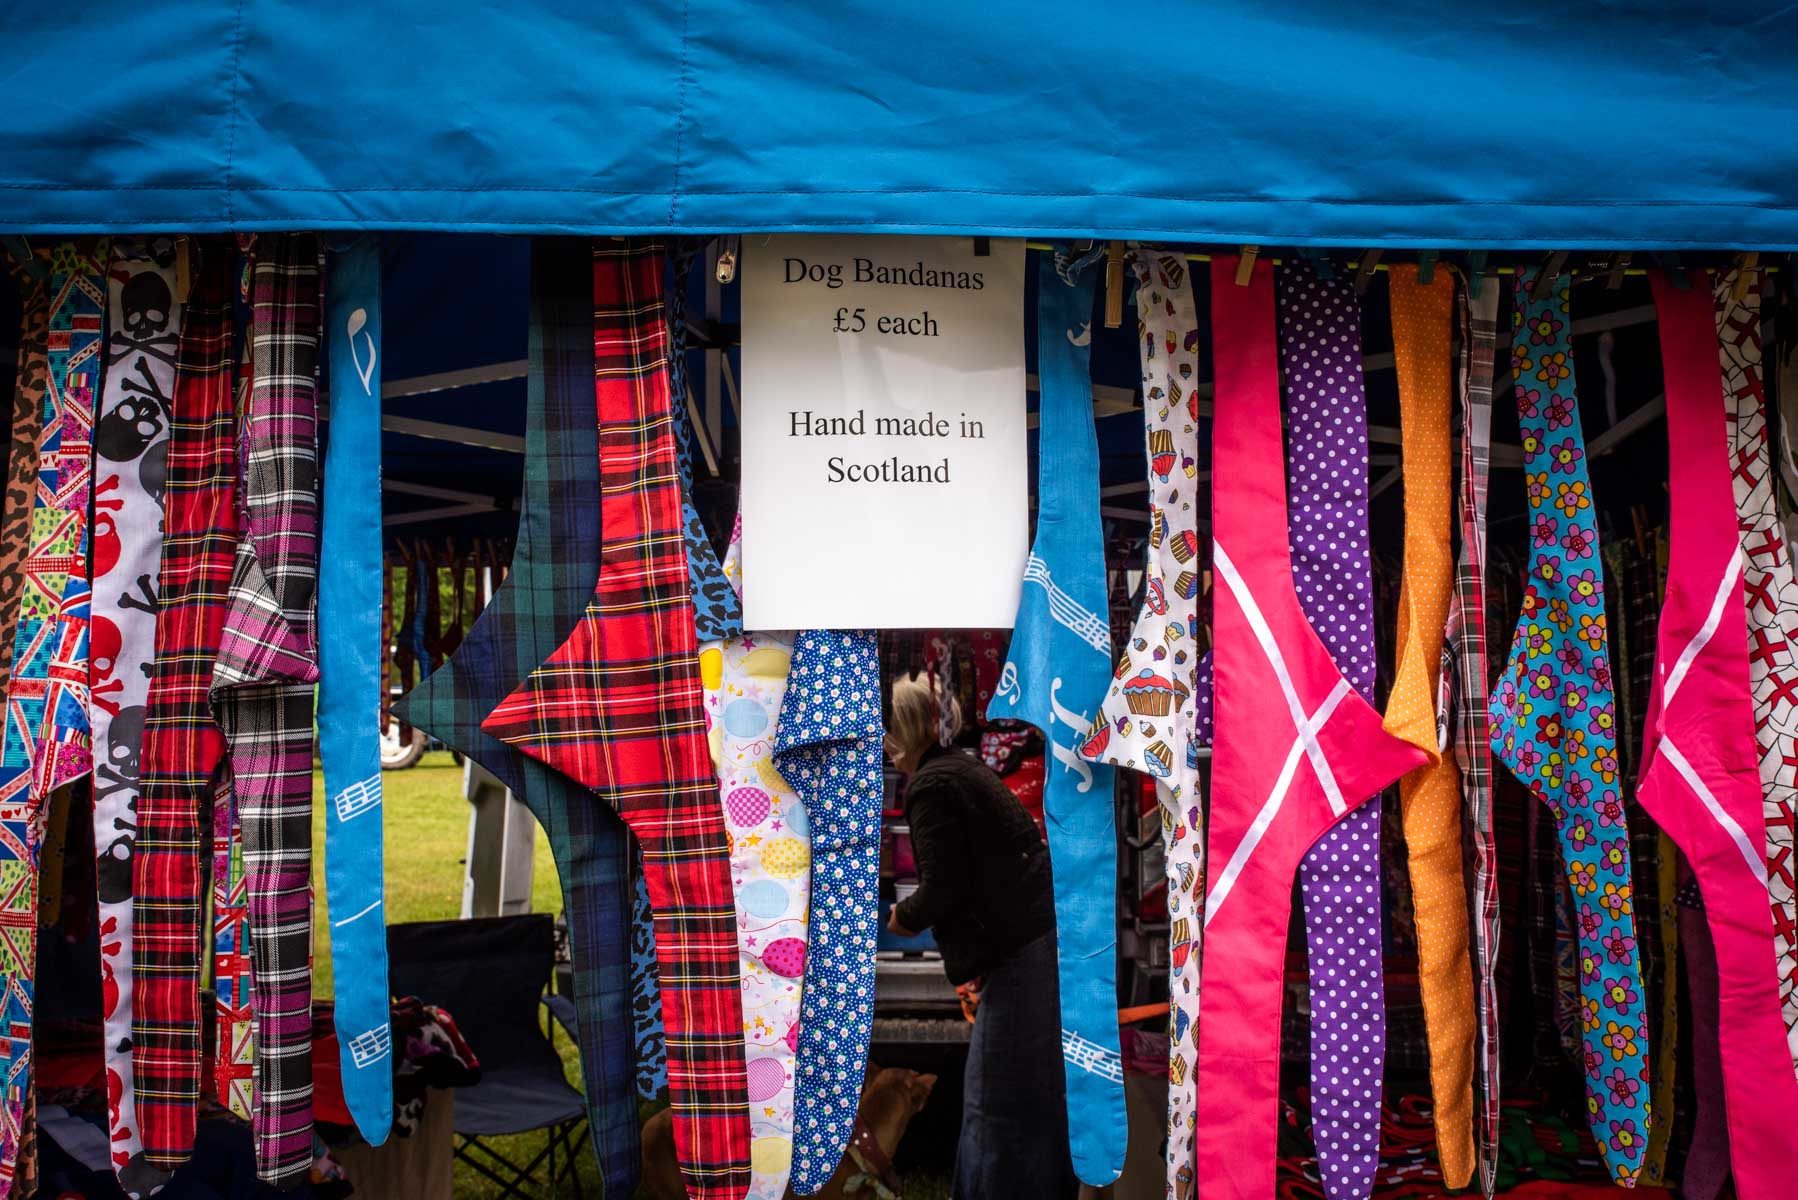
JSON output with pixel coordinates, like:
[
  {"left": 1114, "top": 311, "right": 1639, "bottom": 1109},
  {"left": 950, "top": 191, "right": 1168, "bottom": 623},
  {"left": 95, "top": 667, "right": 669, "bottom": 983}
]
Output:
[{"left": 482, "top": 239, "right": 750, "bottom": 1200}]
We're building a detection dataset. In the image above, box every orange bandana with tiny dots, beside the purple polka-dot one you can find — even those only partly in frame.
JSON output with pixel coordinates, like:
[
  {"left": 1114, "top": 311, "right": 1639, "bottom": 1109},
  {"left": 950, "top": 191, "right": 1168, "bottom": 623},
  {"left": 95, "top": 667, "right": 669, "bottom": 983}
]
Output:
[{"left": 1384, "top": 263, "right": 1474, "bottom": 1189}]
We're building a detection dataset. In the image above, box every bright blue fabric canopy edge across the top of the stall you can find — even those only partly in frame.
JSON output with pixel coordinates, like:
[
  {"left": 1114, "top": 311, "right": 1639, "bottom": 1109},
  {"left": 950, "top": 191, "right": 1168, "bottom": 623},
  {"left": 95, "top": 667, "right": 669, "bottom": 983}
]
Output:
[{"left": 0, "top": 0, "right": 1798, "bottom": 248}]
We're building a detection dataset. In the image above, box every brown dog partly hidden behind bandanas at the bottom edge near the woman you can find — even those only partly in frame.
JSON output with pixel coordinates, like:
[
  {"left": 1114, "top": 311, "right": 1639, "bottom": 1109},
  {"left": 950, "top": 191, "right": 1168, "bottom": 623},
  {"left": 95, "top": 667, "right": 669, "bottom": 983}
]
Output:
[{"left": 644, "top": 1063, "right": 937, "bottom": 1200}]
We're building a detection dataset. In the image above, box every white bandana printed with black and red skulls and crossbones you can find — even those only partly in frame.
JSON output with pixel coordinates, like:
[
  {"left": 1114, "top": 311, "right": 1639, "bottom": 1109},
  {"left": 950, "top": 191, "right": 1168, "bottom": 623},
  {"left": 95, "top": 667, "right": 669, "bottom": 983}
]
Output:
[{"left": 88, "top": 239, "right": 182, "bottom": 1189}]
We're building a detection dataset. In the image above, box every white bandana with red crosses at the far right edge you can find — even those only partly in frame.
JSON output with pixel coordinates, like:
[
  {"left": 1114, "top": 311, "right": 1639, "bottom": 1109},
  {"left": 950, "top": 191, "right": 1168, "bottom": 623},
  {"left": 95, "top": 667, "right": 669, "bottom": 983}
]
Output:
[{"left": 1715, "top": 272, "right": 1798, "bottom": 1067}]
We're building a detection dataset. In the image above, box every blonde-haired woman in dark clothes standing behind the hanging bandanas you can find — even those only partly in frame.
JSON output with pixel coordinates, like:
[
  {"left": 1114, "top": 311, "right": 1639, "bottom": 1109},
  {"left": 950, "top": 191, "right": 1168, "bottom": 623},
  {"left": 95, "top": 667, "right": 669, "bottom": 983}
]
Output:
[{"left": 886, "top": 676, "right": 1075, "bottom": 1200}]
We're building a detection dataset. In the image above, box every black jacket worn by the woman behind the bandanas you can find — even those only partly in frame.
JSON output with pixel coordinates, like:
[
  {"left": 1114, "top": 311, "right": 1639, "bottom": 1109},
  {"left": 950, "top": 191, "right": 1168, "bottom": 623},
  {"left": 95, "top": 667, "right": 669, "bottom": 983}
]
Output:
[{"left": 897, "top": 748, "right": 1055, "bottom": 984}]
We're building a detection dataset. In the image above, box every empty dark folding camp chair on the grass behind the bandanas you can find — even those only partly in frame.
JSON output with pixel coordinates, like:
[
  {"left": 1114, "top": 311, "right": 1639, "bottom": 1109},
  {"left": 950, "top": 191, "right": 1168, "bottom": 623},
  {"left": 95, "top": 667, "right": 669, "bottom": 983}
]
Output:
[{"left": 387, "top": 914, "right": 586, "bottom": 1200}]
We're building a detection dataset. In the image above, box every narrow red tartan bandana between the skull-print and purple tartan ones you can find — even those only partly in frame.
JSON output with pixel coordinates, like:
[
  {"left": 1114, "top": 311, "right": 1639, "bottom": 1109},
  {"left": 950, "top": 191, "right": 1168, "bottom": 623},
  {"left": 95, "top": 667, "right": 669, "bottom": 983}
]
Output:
[{"left": 131, "top": 239, "right": 237, "bottom": 1171}]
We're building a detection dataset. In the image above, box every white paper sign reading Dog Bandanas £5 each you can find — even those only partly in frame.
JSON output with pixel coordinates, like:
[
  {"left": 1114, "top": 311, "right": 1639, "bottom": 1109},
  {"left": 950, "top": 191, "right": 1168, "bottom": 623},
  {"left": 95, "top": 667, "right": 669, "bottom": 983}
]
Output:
[{"left": 741, "top": 236, "right": 1028, "bottom": 630}]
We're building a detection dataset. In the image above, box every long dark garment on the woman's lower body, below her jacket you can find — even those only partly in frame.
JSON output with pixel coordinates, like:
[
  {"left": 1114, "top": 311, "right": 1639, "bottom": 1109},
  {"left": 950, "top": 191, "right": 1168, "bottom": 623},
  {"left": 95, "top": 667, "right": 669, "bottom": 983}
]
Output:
[{"left": 951, "top": 932, "right": 1075, "bottom": 1200}]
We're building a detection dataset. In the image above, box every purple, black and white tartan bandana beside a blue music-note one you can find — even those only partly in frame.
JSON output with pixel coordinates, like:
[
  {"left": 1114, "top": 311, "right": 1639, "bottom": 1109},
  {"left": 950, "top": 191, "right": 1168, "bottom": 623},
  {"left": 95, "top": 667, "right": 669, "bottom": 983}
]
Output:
[{"left": 212, "top": 234, "right": 322, "bottom": 1184}]
